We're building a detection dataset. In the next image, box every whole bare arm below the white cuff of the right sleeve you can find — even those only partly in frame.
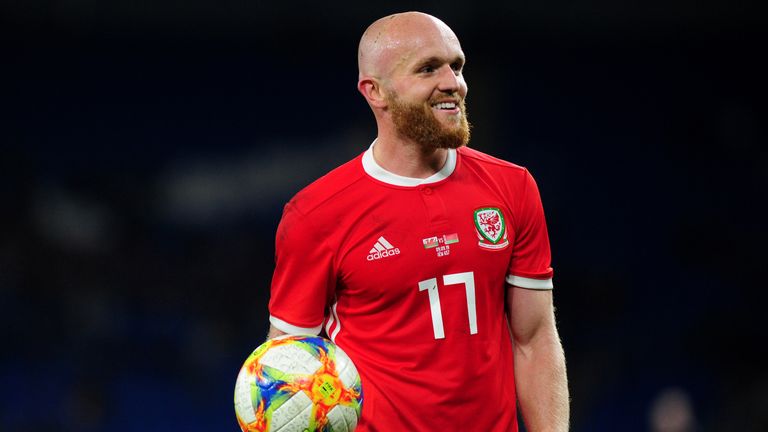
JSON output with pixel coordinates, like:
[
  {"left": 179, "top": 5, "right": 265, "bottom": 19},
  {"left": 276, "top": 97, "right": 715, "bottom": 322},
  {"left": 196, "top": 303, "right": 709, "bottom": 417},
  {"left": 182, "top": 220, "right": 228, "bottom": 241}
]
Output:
[{"left": 507, "top": 285, "right": 569, "bottom": 432}]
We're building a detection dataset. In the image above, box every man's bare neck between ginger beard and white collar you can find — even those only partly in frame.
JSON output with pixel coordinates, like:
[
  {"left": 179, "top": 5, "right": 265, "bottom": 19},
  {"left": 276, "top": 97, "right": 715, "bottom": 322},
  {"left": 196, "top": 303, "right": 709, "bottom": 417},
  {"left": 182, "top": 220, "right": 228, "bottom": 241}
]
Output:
[{"left": 373, "top": 136, "right": 448, "bottom": 179}]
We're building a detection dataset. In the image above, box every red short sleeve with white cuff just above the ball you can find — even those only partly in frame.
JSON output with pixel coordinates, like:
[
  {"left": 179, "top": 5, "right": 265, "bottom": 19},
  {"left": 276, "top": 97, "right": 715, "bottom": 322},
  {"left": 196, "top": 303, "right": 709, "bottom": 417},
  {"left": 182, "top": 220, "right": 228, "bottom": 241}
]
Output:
[{"left": 269, "top": 203, "right": 336, "bottom": 334}]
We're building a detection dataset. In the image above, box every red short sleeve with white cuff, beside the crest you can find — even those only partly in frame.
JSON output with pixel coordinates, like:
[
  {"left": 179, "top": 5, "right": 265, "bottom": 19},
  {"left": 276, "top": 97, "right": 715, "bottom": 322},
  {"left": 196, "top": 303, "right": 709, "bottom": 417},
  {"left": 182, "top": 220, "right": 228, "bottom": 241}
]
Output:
[{"left": 507, "top": 170, "right": 553, "bottom": 290}]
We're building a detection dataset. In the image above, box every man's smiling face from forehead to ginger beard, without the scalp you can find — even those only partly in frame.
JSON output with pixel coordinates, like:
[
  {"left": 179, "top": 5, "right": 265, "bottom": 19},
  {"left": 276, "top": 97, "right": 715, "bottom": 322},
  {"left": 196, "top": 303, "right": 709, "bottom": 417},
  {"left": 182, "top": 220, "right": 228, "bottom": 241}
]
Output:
[{"left": 384, "top": 21, "right": 470, "bottom": 150}]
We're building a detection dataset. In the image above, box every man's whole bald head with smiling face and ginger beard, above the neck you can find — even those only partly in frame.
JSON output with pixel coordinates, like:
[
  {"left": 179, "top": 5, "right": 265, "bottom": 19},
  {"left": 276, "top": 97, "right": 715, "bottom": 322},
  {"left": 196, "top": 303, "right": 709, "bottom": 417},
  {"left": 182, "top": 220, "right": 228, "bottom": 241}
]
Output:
[{"left": 359, "top": 12, "right": 470, "bottom": 149}]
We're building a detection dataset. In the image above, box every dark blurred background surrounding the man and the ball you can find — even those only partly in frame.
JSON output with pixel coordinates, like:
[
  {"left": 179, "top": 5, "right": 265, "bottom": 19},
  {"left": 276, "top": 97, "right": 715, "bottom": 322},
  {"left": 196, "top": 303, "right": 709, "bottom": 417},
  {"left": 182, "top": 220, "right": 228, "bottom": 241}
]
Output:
[{"left": 0, "top": 0, "right": 768, "bottom": 432}]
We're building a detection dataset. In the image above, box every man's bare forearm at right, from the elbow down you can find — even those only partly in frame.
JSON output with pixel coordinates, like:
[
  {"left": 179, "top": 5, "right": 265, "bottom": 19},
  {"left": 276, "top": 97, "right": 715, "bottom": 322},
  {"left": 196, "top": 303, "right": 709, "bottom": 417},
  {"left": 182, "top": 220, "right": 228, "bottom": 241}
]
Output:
[{"left": 514, "top": 327, "right": 570, "bottom": 432}]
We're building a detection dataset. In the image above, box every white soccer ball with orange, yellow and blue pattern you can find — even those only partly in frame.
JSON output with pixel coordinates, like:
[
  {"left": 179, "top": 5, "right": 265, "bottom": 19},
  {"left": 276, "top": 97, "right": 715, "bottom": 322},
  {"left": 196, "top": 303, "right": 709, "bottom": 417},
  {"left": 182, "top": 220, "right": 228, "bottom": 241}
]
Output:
[{"left": 235, "top": 335, "right": 363, "bottom": 432}]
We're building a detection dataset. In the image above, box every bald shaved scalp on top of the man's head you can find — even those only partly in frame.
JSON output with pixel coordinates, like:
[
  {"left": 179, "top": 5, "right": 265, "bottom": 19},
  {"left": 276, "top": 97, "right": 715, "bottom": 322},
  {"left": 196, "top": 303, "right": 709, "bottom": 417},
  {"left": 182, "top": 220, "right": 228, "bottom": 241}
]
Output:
[{"left": 357, "top": 12, "right": 459, "bottom": 79}]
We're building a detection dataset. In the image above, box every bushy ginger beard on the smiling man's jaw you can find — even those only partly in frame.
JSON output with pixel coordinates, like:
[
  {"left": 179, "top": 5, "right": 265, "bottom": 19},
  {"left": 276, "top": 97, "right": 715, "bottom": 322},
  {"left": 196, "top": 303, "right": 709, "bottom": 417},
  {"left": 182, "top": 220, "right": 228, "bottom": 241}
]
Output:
[{"left": 387, "top": 93, "right": 471, "bottom": 152}]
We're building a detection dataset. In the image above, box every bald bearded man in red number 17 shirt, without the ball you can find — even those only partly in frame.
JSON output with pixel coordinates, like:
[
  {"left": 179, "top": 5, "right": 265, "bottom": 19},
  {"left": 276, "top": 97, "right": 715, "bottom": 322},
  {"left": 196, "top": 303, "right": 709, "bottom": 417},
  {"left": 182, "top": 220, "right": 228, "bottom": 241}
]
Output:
[{"left": 269, "top": 12, "right": 569, "bottom": 432}]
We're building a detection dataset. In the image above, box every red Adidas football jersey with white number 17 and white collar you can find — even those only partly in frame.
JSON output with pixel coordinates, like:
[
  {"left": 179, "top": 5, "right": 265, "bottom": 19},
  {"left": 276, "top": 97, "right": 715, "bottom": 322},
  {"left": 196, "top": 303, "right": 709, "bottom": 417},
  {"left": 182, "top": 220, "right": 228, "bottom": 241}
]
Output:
[{"left": 269, "top": 143, "right": 552, "bottom": 432}]
